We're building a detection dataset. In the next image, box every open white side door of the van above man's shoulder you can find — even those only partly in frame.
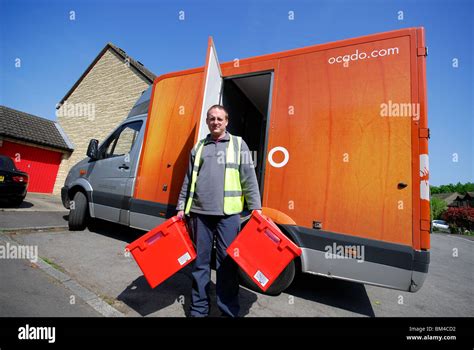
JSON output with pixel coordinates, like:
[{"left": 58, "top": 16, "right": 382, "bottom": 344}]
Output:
[{"left": 196, "top": 36, "right": 222, "bottom": 142}]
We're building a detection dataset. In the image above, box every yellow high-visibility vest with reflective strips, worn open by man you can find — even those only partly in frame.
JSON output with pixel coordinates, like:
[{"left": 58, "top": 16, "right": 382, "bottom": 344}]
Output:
[{"left": 184, "top": 134, "right": 244, "bottom": 215}]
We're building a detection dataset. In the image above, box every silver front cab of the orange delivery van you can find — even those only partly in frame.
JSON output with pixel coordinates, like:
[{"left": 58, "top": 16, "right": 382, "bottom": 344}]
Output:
[{"left": 61, "top": 86, "right": 156, "bottom": 230}]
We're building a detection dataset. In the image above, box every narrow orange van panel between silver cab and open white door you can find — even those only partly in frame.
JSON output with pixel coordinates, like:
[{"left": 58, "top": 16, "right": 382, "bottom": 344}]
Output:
[{"left": 134, "top": 73, "right": 202, "bottom": 204}]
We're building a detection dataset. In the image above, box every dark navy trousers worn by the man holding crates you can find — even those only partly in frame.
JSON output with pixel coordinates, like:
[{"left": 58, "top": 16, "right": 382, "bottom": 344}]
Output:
[{"left": 190, "top": 213, "right": 240, "bottom": 317}]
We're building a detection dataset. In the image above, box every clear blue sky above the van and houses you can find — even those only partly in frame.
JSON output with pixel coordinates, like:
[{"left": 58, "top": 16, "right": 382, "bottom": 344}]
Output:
[{"left": 0, "top": 0, "right": 474, "bottom": 185}]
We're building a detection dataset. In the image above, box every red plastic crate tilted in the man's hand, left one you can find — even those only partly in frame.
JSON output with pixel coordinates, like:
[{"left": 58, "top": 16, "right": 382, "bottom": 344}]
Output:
[{"left": 126, "top": 216, "right": 196, "bottom": 288}]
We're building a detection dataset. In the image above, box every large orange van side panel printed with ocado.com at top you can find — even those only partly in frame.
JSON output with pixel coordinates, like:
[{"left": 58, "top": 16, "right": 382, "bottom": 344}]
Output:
[{"left": 264, "top": 35, "right": 412, "bottom": 246}]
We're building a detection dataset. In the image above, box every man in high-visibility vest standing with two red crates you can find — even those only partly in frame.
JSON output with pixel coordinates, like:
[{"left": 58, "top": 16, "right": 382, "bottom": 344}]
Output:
[{"left": 177, "top": 105, "right": 262, "bottom": 317}]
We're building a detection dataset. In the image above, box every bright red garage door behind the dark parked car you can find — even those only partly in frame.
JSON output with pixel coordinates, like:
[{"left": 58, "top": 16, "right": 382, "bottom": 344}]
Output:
[{"left": 0, "top": 141, "right": 61, "bottom": 193}]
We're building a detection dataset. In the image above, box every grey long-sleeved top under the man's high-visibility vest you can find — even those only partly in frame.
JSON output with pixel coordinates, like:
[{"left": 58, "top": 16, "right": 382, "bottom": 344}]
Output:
[{"left": 176, "top": 132, "right": 262, "bottom": 215}]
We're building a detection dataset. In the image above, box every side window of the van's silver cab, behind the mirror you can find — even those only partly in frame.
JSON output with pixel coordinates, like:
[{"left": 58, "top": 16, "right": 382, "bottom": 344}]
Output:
[{"left": 102, "top": 121, "right": 143, "bottom": 158}]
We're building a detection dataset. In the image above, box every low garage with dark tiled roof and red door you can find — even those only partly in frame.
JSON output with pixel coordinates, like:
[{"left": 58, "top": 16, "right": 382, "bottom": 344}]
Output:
[{"left": 0, "top": 106, "right": 74, "bottom": 193}]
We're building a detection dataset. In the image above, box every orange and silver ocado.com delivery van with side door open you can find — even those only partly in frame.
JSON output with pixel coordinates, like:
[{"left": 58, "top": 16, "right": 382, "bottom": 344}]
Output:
[{"left": 62, "top": 28, "right": 431, "bottom": 294}]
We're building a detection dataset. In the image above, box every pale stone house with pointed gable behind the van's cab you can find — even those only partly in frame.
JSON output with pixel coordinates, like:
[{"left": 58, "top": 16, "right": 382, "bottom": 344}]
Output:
[{"left": 54, "top": 43, "right": 156, "bottom": 193}]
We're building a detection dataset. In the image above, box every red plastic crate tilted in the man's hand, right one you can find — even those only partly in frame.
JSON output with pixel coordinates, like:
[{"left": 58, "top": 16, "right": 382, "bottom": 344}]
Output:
[{"left": 227, "top": 211, "right": 301, "bottom": 291}]
